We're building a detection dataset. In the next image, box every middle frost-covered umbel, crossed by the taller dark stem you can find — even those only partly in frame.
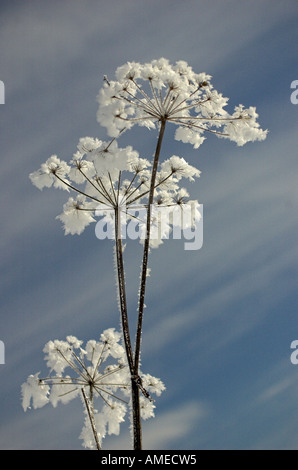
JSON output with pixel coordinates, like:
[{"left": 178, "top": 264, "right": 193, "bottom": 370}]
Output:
[{"left": 30, "top": 137, "right": 201, "bottom": 241}]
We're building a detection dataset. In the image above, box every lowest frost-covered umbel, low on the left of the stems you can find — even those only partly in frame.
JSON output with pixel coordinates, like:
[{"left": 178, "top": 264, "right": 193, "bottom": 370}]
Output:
[{"left": 22, "top": 328, "right": 165, "bottom": 449}]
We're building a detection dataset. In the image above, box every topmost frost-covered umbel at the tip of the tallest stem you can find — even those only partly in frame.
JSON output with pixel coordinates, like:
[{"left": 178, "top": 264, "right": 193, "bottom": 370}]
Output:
[{"left": 97, "top": 58, "right": 267, "bottom": 148}]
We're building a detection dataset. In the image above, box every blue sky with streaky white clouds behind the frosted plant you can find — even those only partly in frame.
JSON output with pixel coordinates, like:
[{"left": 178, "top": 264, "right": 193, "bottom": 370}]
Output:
[{"left": 0, "top": 0, "right": 298, "bottom": 450}]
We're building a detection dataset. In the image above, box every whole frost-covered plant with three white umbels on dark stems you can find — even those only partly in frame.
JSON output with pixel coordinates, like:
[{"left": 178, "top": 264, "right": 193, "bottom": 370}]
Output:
[{"left": 22, "top": 58, "right": 267, "bottom": 450}]
